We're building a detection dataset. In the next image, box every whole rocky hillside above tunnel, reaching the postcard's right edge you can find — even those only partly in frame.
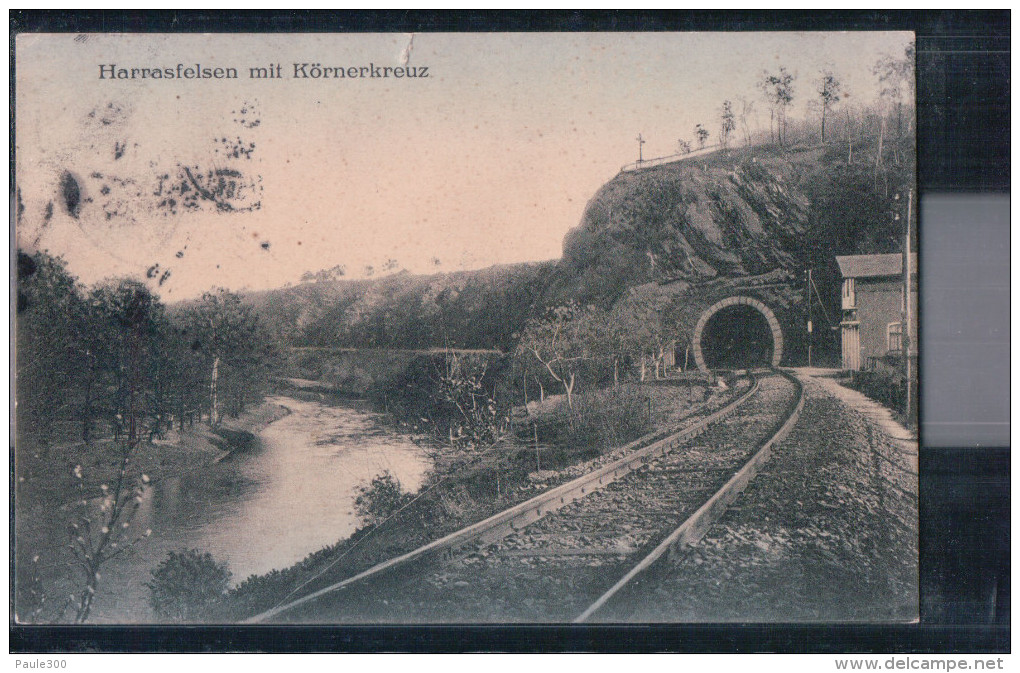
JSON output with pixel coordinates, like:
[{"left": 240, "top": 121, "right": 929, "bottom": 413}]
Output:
[{"left": 547, "top": 138, "right": 916, "bottom": 314}]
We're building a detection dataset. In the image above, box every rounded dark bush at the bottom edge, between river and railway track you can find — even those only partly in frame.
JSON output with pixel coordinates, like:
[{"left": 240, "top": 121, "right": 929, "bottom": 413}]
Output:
[{"left": 146, "top": 550, "right": 231, "bottom": 622}]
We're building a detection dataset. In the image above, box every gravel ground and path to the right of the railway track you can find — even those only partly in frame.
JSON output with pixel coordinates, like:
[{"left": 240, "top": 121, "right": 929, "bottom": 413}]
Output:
[{"left": 595, "top": 372, "right": 918, "bottom": 622}]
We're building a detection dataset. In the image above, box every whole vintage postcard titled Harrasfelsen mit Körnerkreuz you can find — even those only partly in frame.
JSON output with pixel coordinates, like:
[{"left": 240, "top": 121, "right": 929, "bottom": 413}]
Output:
[{"left": 12, "top": 32, "right": 918, "bottom": 624}]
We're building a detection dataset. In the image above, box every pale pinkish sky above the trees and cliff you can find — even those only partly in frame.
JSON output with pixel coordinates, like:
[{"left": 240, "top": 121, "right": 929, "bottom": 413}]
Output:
[{"left": 15, "top": 33, "right": 913, "bottom": 301}]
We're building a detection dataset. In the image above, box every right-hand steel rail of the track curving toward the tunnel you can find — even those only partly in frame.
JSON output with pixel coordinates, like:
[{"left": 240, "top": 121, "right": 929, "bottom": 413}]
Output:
[{"left": 573, "top": 370, "right": 804, "bottom": 624}]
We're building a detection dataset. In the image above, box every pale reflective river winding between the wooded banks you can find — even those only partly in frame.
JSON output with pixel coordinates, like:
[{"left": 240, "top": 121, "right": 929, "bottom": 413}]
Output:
[{"left": 90, "top": 397, "right": 431, "bottom": 623}]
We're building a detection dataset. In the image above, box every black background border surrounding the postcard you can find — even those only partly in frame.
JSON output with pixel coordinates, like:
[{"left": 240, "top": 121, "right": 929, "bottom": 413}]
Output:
[{"left": 9, "top": 10, "right": 1010, "bottom": 654}]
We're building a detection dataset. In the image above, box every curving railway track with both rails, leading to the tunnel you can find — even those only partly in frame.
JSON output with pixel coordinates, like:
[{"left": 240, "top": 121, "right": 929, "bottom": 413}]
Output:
[{"left": 249, "top": 372, "right": 803, "bottom": 623}]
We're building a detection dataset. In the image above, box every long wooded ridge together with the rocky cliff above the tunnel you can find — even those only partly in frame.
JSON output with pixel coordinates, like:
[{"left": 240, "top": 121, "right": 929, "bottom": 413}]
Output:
[{"left": 240, "top": 138, "right": 914, "bottom": 350}]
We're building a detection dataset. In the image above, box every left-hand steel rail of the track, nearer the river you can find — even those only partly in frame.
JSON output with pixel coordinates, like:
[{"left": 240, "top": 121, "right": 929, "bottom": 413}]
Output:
[{"left": 241, "top": 377, "right": 760, "bottom": 624}]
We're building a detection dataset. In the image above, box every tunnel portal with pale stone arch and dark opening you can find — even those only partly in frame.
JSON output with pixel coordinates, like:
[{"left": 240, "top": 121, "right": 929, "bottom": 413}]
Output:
[{"left": 692, "top": 297, "right": 782, "bottom": 371}]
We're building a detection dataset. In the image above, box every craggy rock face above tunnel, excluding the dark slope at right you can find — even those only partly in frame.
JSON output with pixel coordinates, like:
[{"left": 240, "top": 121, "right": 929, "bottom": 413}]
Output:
[{"left": 553, "top": 150, "right": 820, "bottom": 303}]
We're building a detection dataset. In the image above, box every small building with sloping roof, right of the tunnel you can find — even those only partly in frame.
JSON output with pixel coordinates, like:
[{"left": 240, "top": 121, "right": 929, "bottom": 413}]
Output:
[{"left": 835, "top": 253, "right": 917, "bottom": 371}]
